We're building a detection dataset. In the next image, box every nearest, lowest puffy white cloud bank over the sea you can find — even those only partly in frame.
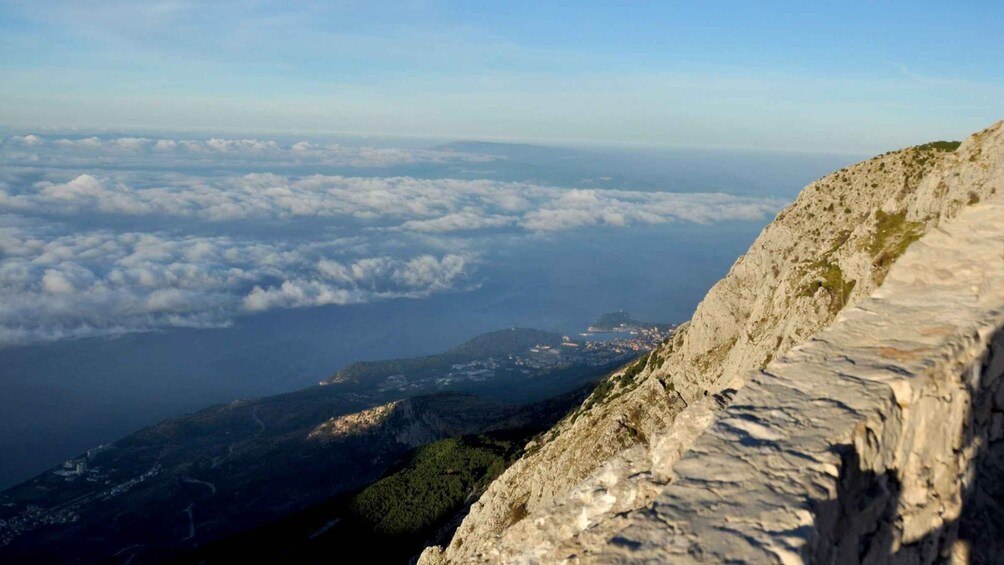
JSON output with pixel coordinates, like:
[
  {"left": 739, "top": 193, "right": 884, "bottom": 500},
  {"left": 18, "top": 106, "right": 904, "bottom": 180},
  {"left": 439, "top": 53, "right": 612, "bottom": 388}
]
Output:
[{"left": 0, "top": 216, "right": 474, "bottom": 344}]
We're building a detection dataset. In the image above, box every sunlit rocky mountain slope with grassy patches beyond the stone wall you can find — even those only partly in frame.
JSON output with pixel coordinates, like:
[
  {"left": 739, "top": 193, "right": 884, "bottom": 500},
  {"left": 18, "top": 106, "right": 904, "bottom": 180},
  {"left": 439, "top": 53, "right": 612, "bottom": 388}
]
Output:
[{"left": 422, "top": 122, "right": 1004, "bottom": 563}]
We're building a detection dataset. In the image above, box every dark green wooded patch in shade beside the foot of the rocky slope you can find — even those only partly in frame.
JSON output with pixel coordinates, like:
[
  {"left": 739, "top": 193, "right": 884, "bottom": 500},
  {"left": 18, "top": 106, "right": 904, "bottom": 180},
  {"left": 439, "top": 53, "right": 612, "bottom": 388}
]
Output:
[{"left": 349, "top": 436, "right": 519, "bottom": 536}]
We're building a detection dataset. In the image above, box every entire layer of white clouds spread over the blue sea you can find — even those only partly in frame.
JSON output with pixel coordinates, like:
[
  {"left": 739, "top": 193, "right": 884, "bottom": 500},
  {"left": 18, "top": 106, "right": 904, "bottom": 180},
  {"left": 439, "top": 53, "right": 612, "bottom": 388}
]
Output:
[{"left": 0, "top": 135, "right": 781, "bottom": 344}]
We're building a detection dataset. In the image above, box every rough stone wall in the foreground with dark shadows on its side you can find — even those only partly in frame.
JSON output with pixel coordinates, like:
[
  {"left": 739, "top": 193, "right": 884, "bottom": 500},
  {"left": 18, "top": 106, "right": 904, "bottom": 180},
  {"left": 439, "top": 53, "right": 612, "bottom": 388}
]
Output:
[{"left": 570, "top": 200, "right": 1004, "bottom": 563}]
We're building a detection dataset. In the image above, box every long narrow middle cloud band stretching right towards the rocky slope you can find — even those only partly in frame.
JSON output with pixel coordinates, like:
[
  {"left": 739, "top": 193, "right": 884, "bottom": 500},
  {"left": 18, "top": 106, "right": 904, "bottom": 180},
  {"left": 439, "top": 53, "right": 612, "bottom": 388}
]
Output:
[{"left": 0, "top": 174, "right": 780, "bottom": 233}]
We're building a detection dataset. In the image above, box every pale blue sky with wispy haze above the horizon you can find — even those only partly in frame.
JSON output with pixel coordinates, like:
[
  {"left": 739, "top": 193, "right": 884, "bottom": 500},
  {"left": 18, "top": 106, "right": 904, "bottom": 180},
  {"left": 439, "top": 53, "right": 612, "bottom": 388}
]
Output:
[{"left": 0, "top": 0, "right": 1004, "bottom": 153}]
